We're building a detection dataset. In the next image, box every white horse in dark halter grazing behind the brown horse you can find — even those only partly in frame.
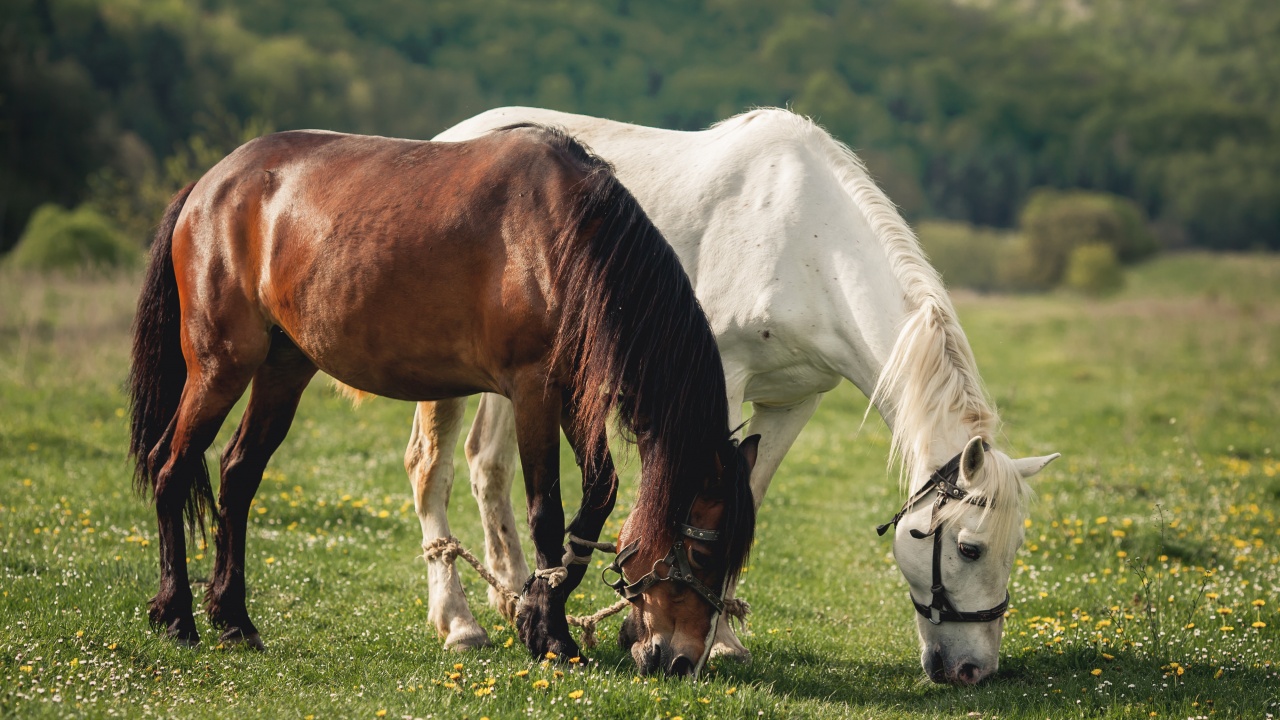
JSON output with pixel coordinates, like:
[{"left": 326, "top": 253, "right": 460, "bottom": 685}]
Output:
[{"left": 404, "top": 108, "right": 1057, "bottom": 683}]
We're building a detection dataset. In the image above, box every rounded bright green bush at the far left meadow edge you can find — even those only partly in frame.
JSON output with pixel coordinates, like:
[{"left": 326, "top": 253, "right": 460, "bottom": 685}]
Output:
[{"left": 8, "top": 204, "right": 142, "bottom": 272}]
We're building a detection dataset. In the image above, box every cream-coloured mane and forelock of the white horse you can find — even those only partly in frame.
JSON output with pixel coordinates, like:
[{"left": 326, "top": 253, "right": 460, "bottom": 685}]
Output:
[{"left": 724, "top": 106, "right": 1030, "bottom": 543}]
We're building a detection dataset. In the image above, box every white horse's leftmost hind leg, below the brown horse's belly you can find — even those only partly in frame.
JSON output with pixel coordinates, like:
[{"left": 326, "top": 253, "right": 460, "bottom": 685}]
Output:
[{"left": 404, "top": 397, "right": 488, "bottom": 651}]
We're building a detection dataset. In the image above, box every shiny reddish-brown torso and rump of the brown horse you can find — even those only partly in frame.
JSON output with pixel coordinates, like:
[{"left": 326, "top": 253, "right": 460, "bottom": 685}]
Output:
[{"left": 173, "top": 129, "right": 599, "bottom": 400}]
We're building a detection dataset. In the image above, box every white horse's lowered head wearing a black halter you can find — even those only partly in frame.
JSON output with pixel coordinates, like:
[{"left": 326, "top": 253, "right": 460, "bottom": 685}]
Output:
[{"left": 893, "top": 437, "right": 1059, "bottom": 684}]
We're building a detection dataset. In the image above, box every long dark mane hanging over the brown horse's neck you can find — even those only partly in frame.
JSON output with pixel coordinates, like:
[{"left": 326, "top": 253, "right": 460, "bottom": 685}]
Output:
[{"left": 499, "top": 124, "right": 755, "bottom": 578}]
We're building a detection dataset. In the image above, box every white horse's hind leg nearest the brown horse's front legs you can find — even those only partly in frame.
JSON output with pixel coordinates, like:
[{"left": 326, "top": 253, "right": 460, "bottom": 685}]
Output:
[{"left": 466, "top": 392, "right": 529, "bottom": 618}]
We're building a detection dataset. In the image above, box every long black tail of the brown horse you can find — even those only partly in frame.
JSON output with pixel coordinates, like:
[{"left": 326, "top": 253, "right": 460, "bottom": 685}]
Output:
[{"left": 129, "top": 183, "right": 214, "bottom": 533}]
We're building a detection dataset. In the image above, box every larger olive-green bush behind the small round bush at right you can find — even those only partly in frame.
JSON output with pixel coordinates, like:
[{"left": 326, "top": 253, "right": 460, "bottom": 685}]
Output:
[{"left": 1019, "top": 190, "right": 1158, "bottom": 287}]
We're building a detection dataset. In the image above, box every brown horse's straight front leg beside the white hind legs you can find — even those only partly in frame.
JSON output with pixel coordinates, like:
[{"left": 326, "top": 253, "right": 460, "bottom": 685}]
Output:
[{"left": 512, "top": 374, "right": 579, "bottom": 660}]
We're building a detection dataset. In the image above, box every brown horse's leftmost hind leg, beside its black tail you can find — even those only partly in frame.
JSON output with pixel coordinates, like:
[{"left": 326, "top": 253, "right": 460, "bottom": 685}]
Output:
[{"left": 147, "top": 347, "right": 262, "bottom": 646}]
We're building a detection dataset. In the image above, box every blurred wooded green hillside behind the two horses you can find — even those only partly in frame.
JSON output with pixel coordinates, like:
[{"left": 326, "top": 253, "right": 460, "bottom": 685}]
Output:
[{"left": 0, "top": 0, "right": 1280, "bottom": 254}]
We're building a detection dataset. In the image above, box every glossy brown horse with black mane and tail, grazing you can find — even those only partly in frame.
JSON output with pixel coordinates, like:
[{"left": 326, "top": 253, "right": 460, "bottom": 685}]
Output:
[{"left": 129, "top": 127, "right": 756, "bottom": 674}]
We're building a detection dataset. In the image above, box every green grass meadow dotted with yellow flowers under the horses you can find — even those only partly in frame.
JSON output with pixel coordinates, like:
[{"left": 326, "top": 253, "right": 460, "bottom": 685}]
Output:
[{"left": 0, "top": 255, "right": 1280, "bottom": 720}]
